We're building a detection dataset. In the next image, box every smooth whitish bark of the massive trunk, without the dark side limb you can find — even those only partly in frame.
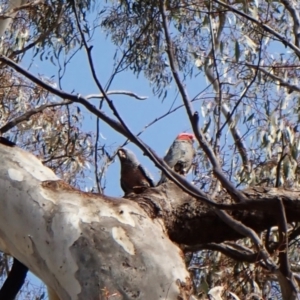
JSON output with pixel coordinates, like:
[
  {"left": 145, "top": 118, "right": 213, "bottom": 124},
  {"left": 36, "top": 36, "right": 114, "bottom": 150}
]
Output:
[{"left": 0, "top": 144, "right": 191, "bottom": 300}]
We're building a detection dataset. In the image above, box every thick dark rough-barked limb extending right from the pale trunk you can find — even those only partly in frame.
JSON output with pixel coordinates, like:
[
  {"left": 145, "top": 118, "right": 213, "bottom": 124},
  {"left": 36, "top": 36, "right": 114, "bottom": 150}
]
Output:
[{"left": 136, "top": 181, "right": 300, "bottom": 246}]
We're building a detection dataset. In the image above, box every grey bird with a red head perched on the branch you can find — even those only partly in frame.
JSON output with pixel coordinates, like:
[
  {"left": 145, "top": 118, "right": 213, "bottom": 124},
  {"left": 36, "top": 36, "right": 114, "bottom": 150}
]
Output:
[{"left": 158, "top": 132, "right": 196, "bottom": 184}]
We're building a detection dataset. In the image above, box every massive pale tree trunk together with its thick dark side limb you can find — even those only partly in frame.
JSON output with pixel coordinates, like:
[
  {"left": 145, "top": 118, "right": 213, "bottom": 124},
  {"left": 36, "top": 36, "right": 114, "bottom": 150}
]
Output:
[{"left": 0, "top": 144, "right": 300, "bottom": 300}]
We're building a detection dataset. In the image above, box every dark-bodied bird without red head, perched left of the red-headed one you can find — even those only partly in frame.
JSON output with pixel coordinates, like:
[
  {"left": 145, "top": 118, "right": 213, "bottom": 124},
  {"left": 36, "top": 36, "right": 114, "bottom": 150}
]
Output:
[{"left": 117, "top": 148, "right": 154, "bottom": 195}]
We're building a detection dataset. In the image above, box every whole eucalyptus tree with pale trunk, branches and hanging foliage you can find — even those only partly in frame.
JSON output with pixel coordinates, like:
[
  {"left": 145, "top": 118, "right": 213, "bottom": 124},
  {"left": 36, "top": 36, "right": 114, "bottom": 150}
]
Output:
[{"left": 0, "top": 0, "right": 300, "bottom": 299}]
